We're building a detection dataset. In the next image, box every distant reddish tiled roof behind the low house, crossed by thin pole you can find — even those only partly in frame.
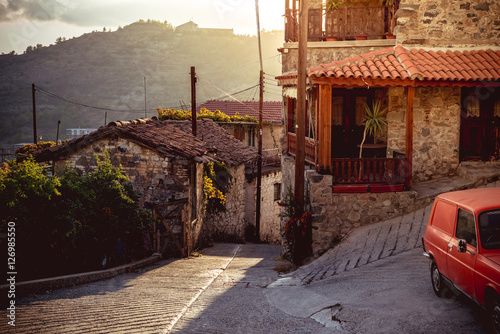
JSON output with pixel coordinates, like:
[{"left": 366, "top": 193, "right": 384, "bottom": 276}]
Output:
[{"left": 196, "top": 100, "right": 283, "bottom": 123}]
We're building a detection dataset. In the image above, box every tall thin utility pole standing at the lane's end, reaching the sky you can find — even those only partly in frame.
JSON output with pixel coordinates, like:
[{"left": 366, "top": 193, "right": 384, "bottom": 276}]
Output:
[{"left": 255, "top": 0, "right": 264, "bottom": 242}]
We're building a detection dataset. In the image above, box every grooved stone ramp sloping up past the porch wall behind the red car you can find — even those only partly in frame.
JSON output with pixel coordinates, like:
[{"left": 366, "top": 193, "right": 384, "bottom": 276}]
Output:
[{"left": 273, "top": 170, "right": 500, "bottom": 286}]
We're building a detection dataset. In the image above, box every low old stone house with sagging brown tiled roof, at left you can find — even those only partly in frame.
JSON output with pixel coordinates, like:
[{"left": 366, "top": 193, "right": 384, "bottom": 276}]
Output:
[{"left": 35, "top": 119, "right": 256, "bottom": 255}]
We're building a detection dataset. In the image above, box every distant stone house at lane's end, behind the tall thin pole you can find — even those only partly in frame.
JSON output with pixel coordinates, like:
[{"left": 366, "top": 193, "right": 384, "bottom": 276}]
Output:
[{"left": 198, "top": 100, "right": 283, "bottom": 243}]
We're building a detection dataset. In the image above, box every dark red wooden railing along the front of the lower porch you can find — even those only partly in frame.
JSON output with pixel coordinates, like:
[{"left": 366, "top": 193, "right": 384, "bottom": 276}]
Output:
[{"left": 331, "top": 158, "right": 408, "bottom": 185}]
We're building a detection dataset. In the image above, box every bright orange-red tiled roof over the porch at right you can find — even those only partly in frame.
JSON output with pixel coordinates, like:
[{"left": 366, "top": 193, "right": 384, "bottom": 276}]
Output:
[{"left": 278, "top": 45, "right": 500, "bottom": 82}]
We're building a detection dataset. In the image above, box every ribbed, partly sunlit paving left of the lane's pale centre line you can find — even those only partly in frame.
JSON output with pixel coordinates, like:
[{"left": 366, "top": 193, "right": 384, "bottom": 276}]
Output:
[{"left": 0, "top": 244, "right": 244, "bottom": 333}]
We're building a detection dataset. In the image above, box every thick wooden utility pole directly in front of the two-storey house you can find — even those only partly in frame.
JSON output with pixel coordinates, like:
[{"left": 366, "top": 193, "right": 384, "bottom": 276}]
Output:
[{"left": 295, "top": 0, "right": 309, "bottom": 215}]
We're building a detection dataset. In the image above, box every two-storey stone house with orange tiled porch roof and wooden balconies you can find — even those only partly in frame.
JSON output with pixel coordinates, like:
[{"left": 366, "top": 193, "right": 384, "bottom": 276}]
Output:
[{"left": 278, "top": 0, "right": 500, "bottom": 255}]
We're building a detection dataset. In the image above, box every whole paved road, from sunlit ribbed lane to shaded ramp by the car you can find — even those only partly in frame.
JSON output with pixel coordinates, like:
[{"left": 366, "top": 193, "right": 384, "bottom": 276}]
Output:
[{"left": 4, "top": 182, "right": 500, "bottom": 334}]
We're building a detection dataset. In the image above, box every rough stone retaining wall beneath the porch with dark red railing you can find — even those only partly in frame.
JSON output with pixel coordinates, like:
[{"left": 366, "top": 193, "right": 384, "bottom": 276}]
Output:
[{"left": 306, "top": 171, "right": 417, "bottom": 256}]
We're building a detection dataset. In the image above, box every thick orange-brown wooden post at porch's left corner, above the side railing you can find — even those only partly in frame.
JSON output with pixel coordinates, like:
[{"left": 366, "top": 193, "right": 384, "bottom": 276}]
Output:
[{"left": 317, "top": 85, "right": 332, "bottom": 169}]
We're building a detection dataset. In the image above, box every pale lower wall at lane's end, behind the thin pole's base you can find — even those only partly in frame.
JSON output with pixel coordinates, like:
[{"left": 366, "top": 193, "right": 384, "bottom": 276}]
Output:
[{"left": 245, "top": 168, "right": 281, "bottom": 244}]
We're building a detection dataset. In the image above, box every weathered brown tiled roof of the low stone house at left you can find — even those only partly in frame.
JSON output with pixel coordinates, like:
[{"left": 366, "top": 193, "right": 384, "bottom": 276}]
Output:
[{"left": 33, "top": 119, "right": 256, "bottom": 166}]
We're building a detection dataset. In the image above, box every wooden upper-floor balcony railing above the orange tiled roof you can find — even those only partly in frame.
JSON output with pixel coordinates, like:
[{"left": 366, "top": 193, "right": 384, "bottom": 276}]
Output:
[{"left": 285, "top": 6, "right": 395, "bottom": 42}]
